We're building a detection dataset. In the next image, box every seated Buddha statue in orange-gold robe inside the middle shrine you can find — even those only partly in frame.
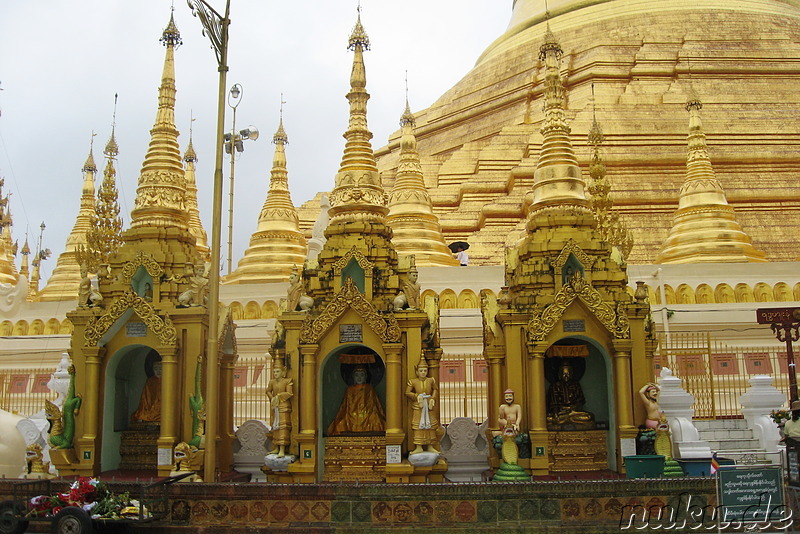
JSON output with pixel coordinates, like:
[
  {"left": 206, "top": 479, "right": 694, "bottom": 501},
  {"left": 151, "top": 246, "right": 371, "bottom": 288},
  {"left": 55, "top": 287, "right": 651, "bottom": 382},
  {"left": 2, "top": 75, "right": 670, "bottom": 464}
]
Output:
[{"left": 328, "top": 365, "right": 386, "bottom": 436}]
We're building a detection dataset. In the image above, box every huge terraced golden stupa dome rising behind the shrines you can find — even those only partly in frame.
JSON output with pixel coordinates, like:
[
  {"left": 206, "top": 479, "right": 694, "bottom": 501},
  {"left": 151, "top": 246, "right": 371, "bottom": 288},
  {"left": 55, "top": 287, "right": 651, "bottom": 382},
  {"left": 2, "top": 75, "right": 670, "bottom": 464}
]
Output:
[{"left": 368, "top": 0, "right": 800, "bottom": 264}]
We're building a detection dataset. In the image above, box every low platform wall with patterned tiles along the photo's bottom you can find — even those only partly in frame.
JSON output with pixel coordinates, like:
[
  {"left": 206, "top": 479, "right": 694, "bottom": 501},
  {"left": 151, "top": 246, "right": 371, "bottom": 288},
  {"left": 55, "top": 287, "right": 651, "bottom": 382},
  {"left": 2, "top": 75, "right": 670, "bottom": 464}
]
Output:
[{"left": 0, "top": 478, "right": 715, "bottom": 534}]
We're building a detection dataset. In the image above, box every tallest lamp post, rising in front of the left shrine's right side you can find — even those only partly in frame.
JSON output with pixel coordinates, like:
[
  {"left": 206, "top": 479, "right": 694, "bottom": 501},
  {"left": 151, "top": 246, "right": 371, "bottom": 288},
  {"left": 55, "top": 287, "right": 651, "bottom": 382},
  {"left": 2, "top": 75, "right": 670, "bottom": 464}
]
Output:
[{"left": 187, "top": 0, "right": 231, "bottom": 482}]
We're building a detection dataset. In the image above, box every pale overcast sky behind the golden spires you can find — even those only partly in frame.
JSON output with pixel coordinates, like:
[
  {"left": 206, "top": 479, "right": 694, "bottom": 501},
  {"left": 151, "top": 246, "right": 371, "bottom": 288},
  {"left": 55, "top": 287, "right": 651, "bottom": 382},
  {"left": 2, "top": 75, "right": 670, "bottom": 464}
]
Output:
[{"left": 0, "top": 0, "right": 512, "bottom": 286}]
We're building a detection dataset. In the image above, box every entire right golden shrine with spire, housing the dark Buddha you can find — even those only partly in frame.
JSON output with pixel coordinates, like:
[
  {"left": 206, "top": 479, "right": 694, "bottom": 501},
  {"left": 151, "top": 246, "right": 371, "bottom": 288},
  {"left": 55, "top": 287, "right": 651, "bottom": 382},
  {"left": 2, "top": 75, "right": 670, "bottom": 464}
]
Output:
[{"left": 481, "top": 26, "right": 650, "bottom": 476}]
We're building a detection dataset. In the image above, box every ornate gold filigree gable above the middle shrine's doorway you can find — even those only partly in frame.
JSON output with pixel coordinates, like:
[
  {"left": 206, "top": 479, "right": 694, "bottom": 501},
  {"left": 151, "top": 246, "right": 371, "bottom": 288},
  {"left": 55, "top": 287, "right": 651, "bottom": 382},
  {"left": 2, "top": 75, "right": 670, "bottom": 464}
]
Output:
[{"left": 300, "top": 278, "right": 400, "bottom": 343}]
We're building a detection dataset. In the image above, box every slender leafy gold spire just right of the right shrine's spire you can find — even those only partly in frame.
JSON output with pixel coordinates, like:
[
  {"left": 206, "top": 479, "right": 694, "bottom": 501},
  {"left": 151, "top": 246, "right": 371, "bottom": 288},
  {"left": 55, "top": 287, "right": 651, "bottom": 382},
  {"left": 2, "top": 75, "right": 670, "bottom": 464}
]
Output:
[{"left": 587, "top": 99, "right": 633, "bottom": 264}]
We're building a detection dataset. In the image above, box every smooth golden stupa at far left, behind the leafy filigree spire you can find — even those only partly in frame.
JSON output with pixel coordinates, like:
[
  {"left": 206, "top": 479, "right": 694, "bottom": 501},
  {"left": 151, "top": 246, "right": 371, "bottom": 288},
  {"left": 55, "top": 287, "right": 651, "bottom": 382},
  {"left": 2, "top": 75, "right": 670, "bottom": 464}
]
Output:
[{"left": 39, "top": 141, "right": 98, "bottom": 301}]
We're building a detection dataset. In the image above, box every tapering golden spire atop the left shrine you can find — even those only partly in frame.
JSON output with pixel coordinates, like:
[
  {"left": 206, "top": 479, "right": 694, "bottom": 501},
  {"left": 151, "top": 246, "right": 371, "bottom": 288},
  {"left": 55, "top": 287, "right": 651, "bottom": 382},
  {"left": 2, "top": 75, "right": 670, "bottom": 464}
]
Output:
[{"left": 131, "top": 15, "right": 189, "bottom": 232}]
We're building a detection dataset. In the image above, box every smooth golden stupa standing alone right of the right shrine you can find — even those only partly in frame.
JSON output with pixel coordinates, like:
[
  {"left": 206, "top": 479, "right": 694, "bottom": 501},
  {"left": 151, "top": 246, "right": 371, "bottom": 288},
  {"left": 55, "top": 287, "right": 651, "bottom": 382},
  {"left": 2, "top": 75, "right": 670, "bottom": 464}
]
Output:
[{"left": 656, "top": 97, "right": 767, "bottom": 263}]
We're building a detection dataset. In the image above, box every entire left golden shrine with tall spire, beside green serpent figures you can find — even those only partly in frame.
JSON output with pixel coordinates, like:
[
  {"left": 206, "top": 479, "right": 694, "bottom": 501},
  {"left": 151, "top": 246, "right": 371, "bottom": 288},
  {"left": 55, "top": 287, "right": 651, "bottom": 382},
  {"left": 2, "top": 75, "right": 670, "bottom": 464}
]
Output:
[{"left": 57, "top": 16, "right": 236, "bottom": 482}]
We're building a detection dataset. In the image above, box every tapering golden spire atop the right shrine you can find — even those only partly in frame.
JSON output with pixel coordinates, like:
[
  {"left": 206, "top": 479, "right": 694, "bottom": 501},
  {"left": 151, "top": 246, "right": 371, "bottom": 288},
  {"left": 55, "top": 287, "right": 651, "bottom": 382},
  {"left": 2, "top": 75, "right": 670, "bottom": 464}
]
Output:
[{"left": 528, "top": 24, "right": 588, "bottom": 222}]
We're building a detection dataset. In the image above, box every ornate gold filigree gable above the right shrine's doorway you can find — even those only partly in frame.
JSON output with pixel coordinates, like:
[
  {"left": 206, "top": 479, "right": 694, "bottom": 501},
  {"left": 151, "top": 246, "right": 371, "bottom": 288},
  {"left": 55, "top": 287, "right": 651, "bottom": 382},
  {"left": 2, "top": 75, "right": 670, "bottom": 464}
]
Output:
[{"left": 528, "top": 272, "right": 631, "bottom": 342}]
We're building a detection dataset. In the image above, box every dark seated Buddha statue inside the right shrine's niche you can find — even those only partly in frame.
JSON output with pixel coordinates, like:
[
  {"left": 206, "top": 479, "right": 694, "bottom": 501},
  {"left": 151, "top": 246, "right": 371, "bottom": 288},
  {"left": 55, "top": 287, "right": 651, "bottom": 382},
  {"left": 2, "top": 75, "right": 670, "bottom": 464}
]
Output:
[{"left": 547, "top": 362, "right": 595, "bottom": 430}]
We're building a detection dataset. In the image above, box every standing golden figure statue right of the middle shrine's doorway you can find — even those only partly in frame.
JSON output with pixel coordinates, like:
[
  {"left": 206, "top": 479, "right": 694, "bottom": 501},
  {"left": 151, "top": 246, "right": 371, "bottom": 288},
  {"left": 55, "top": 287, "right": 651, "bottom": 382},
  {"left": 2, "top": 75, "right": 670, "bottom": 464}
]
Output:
[{"left": 406, "top": 357, "right": 439, "bottom": 454}]
